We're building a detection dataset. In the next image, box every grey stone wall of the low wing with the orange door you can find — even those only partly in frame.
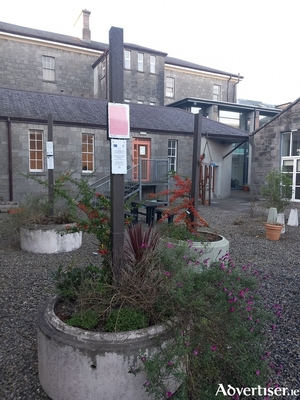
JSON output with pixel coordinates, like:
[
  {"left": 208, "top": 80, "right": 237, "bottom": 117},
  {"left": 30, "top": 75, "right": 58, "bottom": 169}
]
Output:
[{"left": 0, "top": 121, "right": 193, "bottom": 201}]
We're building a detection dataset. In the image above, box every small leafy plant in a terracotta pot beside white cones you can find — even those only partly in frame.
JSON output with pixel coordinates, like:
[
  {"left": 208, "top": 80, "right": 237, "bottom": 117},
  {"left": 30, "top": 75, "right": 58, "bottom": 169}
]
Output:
[{"left": 260, "top": 169, "right": 292, "bottom": 240}]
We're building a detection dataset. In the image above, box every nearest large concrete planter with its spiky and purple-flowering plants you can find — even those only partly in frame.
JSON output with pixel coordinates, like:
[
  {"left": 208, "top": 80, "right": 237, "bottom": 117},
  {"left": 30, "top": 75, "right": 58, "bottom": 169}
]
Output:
[{"left": 38, "top": 170, "right": 278, "bottom": 400}]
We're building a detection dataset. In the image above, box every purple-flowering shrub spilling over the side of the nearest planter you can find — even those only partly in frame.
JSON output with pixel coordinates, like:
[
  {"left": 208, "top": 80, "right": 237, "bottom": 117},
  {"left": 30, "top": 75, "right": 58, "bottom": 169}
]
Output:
[{"left": 129, "top": 253, "right": 280, "bottom": 400}]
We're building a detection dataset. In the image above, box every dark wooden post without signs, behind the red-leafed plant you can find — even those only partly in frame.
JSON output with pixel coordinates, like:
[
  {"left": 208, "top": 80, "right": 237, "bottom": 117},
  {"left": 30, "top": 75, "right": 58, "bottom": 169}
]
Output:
[{"left": 191, "top": 112, "right": 202, "bottom": 221}]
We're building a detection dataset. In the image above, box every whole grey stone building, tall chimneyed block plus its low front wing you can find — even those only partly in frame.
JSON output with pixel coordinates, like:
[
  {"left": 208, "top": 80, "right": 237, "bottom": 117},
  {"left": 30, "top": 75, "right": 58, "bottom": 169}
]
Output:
[{"left": 0, "top": 10, "right": 262, "bottom": 203}]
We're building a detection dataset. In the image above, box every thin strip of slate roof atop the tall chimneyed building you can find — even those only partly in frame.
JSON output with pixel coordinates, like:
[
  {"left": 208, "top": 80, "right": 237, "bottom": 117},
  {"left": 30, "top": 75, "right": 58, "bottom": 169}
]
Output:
[{"left": 0, "top": 21, "right": 243, "bottom": 79}]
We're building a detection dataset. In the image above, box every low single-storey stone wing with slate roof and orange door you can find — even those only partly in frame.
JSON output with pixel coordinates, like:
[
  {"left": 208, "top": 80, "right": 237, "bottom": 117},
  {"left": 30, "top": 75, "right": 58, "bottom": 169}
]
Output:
[{"left": 0, "top": 88, "right": 248, "bottom": 201}]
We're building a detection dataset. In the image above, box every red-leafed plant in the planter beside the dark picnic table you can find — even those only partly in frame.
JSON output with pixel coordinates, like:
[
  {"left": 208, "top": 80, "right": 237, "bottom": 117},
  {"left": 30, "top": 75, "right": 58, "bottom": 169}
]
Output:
[{"left": 149, "top": 174, "right": 208, "bottom": 233}]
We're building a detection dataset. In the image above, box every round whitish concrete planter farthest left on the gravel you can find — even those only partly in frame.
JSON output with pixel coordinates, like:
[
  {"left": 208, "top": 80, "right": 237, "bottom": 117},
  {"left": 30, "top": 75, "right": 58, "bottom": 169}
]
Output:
[{"left": 20, "top": 224, "right": 82, "bottom": 254}]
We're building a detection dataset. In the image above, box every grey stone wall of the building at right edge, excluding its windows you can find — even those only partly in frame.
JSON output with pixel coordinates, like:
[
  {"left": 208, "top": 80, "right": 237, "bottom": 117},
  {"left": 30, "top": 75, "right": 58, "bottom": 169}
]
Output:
[{"left": 250, "top": 102, "right": 300, "bottom": 196}]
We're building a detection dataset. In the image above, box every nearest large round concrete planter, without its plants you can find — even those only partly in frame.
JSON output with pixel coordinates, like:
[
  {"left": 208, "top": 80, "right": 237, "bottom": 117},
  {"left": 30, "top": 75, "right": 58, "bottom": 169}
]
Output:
[{"left": 38, "top": 297, "right": 178, "bottom": 400}]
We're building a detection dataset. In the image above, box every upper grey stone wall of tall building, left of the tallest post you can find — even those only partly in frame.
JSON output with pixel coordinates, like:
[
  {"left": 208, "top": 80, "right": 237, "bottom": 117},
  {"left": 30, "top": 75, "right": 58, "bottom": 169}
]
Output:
[{"left": 0, "top": 39, "right": 98, "bottom": 97}]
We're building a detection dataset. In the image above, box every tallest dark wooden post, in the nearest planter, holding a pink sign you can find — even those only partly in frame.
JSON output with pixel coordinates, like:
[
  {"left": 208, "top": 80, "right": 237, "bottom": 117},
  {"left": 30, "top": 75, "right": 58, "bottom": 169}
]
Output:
[{"left": 109, "top": 27, "right": 124, "bottom": 276}]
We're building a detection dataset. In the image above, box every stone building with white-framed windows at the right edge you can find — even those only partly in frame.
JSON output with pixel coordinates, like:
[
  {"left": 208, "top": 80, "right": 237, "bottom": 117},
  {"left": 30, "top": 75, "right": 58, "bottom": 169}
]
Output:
[{"left": 249, "top": 98, "right": 300, "bottom": 202}]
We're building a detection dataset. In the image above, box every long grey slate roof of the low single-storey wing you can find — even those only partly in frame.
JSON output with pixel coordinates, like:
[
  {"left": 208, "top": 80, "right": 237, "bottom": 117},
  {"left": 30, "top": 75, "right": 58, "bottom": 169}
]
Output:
[{"left": 0, "top": 88, "right": 248, "bottom": 140}]
